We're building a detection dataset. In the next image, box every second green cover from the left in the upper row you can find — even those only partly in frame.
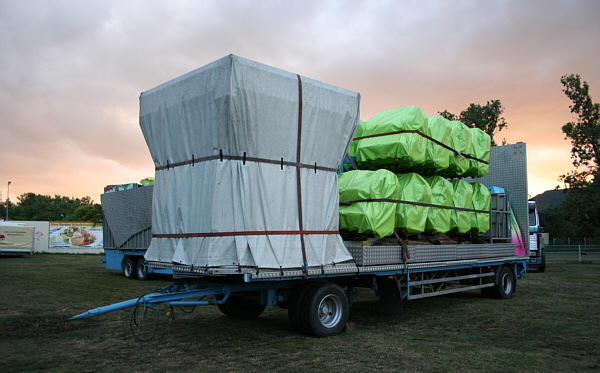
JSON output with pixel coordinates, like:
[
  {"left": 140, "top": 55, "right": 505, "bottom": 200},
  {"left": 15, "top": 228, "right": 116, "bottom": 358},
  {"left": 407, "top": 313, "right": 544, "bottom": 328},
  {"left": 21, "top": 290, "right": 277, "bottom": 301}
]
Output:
[{"left": 424, "top": 115, "right": 453, "bottom": 173}]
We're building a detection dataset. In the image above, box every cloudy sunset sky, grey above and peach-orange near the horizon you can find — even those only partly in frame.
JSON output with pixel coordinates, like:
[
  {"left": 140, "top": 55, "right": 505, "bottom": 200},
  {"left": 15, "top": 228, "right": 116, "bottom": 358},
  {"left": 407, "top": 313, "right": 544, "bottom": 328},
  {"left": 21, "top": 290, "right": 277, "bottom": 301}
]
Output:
[{"left": 0, "top": 0, "right": 600, "bottom": 203}]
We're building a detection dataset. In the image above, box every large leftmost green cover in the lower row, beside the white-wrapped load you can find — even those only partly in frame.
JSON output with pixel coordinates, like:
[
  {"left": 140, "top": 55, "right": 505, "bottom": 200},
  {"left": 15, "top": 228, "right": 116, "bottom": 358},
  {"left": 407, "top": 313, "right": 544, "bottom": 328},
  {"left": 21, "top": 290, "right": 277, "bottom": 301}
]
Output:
[{"left": 339, "top": 170, "right": 399, "bottom": 239}]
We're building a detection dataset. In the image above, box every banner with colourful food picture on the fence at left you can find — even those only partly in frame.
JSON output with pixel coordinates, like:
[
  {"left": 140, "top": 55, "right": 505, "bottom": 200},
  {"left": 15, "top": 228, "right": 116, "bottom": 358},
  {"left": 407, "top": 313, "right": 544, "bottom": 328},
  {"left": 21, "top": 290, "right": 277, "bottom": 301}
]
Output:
[{"left": 48, "top": 221, "right": 103, "bottom": 248}]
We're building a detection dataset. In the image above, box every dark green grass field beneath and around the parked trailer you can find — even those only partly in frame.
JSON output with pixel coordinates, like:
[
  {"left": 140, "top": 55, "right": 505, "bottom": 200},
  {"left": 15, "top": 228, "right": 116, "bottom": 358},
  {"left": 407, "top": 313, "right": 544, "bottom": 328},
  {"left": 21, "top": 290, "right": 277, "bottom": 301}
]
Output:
[{"left": 0, "top": 254, "right": 600, "bottom": 372}]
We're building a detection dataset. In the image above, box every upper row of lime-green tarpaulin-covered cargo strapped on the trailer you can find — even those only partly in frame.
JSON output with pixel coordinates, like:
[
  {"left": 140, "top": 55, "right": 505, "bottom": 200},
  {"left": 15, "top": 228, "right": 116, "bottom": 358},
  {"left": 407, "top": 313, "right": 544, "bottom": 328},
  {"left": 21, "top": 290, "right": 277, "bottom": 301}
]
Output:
[{"left": 344, "top": 106, "right": 491, "bottom": 178}]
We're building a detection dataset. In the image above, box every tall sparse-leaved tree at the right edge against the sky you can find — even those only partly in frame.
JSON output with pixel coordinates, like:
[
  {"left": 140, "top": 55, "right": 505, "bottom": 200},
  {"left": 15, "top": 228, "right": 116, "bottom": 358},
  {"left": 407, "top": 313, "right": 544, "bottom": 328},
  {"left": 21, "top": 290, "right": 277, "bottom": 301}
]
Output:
[{"left": 560, "top": 74, "right": 600, "bottom": 189}]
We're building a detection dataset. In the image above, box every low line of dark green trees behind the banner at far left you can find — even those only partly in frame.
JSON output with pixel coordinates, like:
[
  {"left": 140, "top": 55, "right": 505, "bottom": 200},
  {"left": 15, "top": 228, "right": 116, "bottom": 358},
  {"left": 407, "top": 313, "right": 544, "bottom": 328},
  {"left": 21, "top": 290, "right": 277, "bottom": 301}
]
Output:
[{"left": 0, "top": 193, "right": 102, "bottom": 223}]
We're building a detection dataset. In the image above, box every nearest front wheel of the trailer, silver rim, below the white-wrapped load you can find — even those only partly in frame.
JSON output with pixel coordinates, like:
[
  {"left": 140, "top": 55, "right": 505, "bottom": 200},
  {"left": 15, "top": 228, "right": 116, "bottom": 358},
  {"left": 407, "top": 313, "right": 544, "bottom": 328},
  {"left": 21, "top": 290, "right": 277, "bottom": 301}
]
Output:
[{"left": 301, "top": 283, "right": 349, "bottom": 337}]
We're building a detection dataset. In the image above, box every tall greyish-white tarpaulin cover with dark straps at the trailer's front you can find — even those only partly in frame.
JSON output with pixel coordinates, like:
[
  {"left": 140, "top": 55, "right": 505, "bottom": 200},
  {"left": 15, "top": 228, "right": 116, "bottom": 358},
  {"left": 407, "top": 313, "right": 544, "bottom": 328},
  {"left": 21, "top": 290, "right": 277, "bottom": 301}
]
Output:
[{"left": 140, "top": 55, "right": 360, "bottom": 269}]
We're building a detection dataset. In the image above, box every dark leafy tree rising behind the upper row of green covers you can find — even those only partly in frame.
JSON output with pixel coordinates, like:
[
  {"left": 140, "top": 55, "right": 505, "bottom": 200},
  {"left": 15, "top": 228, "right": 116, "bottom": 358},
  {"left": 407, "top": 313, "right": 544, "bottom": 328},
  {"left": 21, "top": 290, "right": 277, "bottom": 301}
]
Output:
[{"left": 439, "top": 100, "right": 508, "bottom": 145}]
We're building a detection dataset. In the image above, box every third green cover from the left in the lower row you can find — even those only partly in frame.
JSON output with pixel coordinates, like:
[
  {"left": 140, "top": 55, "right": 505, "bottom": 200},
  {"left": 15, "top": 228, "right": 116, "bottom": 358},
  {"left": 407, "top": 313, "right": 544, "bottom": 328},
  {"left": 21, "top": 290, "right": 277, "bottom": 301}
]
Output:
[{"left": 425, "top": 176, "right": 454, "bottom": 234}]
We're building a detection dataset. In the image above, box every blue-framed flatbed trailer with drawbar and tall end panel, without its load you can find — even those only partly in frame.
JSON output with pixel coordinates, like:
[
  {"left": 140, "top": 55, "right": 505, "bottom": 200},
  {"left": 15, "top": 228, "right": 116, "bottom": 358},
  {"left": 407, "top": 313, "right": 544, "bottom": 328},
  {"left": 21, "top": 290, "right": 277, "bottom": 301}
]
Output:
[{"left": 73, "top": 143, "right": 529, "bottom": 339}]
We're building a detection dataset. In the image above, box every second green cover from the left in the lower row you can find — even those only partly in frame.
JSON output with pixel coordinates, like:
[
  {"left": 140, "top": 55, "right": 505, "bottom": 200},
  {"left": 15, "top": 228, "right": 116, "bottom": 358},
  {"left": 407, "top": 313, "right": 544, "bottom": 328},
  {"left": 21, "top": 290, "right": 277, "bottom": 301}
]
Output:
[{"left": 396, "top": 173, "right": 431, "bottom": 235}]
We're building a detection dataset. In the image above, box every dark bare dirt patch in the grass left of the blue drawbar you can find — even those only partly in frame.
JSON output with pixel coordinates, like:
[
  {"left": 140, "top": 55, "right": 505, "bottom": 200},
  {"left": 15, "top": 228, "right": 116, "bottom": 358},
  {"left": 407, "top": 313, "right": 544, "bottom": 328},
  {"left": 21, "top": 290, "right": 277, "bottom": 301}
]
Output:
[{"left": 0, "top": 317, "right": 98, "bottom": 338}]
